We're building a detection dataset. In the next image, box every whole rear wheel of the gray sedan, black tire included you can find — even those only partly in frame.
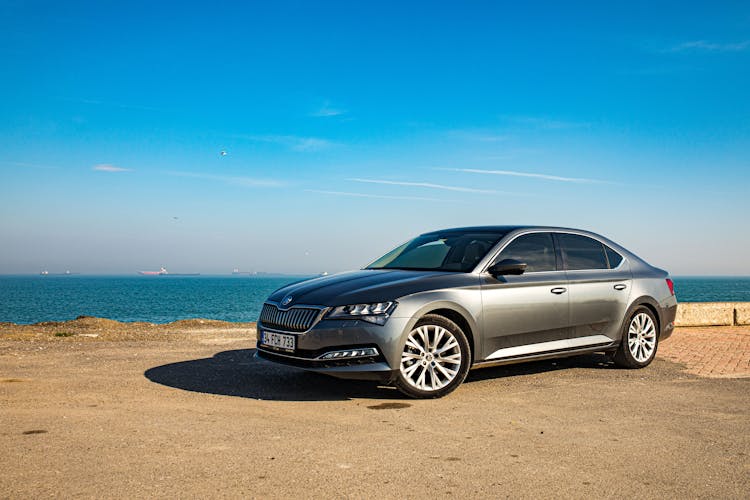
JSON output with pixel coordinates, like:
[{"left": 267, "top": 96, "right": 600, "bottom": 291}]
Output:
[{"left": 614, "top": 306, "right": 659, "bottom": 368}]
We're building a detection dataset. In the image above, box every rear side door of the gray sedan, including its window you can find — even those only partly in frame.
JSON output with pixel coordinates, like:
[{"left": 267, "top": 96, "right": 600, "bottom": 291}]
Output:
[{"left": 555, "top": 233, "right": 632, "bottom": 346}]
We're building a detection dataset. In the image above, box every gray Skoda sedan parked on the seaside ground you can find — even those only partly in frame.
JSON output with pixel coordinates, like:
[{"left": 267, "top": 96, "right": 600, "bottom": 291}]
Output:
[{"left": 256, "top": 226, "right": 677, "bottom": 398}]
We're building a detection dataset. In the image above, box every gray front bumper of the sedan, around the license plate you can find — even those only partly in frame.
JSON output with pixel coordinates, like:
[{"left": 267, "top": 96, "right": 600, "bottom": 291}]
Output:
[{"left": 256, "top": 317, "right": 410, "bottom": 382}]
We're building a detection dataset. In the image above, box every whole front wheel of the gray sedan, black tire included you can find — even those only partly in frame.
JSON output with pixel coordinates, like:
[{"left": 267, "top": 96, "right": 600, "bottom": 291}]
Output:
[{"left": 394, "top": 314, "right": 471, "bottom": 399}]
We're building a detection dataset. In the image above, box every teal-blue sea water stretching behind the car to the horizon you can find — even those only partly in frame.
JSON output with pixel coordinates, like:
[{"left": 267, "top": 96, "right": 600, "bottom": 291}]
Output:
[{"left": 0, "top": 275, "right": 750, "bottom": 323}]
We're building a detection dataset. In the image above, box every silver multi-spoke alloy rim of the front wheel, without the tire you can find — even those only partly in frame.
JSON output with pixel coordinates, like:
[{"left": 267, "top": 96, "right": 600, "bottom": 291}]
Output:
[{"left": 401, "top": 325, "right": 462, "bottom": 391}]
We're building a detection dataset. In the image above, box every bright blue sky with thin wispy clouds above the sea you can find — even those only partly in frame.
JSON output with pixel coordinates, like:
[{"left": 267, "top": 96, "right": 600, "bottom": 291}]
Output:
[{"left": 0, "top": 1, "right": 750, "bottom": 275}]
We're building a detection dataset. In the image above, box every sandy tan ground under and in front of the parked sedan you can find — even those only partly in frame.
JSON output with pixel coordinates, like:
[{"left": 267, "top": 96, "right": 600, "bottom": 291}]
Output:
[{"left": 0, "top": 319, "right": 750, "bottom": 498}]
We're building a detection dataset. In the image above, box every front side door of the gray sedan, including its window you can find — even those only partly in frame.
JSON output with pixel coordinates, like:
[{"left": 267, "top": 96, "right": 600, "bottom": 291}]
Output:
[{"left": 481, "top": 232, "right": 570, "bottom": 360}]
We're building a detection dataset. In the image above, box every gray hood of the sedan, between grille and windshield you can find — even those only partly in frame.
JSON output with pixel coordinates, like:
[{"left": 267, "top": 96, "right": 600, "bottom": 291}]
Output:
[{"left": 268, "top": 269, "right": 477, "bottom": 308}]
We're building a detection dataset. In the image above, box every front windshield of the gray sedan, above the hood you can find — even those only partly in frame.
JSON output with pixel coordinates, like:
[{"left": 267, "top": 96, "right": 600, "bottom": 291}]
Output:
[{"left": 367, "top": 232, "right": 505, "bottom": 273}]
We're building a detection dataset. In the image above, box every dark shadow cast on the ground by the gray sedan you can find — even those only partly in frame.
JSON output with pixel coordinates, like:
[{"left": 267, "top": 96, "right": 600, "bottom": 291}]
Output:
[{"left": 144, "top": 349, "right": 613, "bottom": 401}]
